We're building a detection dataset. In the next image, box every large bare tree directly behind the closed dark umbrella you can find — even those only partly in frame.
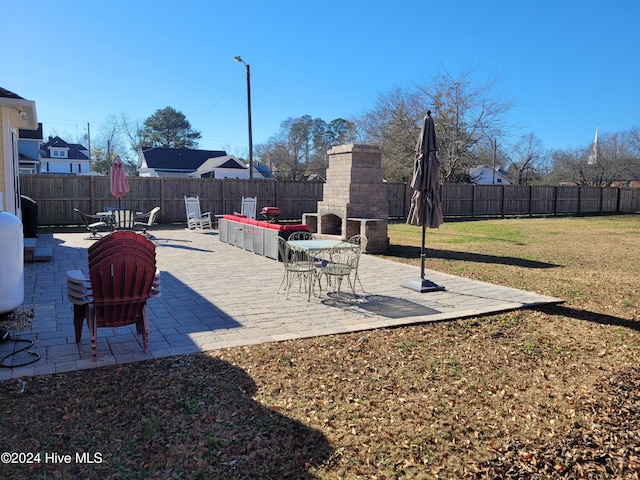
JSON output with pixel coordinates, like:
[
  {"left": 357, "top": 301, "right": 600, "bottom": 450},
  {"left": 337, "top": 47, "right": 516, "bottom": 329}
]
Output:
[{"left": 357, "top": 72, "right": 511, "bottom": 182}]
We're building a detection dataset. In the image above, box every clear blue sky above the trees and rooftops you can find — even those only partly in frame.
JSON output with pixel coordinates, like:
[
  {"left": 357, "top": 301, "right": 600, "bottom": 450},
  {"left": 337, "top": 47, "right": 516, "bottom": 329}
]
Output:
[{"left": 0, "top": 0, "right": 640, "bottom": 156}]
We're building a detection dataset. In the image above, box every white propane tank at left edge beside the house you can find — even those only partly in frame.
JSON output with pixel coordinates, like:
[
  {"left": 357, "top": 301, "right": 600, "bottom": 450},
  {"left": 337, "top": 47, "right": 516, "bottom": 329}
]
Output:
[{"left": 0, "top": 205, "right": 24, "bottom": 314}]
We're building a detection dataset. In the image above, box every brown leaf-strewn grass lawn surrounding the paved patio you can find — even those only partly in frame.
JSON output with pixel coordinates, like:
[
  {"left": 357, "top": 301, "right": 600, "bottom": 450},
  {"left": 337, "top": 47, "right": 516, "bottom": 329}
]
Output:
[{"left": 0, "top": 215, "right": 640, "bottom": 479}]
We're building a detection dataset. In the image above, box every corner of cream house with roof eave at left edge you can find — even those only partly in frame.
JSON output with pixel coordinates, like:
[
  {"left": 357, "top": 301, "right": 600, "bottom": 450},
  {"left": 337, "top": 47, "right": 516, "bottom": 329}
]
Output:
[{"left": 0, "top": 87, "right": 38, "bottom": 214}]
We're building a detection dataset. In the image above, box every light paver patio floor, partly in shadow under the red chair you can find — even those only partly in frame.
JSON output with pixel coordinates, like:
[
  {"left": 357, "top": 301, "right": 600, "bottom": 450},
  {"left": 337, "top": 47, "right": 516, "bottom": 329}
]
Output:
[{"left": 0, "top": 229, "right": 561, "bottom": 380}]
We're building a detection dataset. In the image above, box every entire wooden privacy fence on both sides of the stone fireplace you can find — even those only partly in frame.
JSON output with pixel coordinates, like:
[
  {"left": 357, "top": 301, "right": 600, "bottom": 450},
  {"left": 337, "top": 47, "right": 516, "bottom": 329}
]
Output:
[{"left": 20, "top": 174, "right": 640, "bottom": 225}]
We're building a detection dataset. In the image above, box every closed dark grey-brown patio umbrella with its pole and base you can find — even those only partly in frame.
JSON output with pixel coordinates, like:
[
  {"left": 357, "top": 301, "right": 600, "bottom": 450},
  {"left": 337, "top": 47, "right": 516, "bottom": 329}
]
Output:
[{"left": 402, "top": 110, "right": 444, "bottom": 293}]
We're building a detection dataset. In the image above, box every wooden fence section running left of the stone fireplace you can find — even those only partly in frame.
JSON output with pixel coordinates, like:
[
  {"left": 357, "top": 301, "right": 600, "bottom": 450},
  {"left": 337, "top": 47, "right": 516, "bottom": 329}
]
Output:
[{"left": 20, "top": 174, "right": 323, "bottom": 225}]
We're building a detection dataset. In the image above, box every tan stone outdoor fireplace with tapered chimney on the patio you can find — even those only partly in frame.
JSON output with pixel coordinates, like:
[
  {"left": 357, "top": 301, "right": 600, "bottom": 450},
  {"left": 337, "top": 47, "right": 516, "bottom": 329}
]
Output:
[{"left": 302, "top": 144, "right": 389, "bottom": 253}]
